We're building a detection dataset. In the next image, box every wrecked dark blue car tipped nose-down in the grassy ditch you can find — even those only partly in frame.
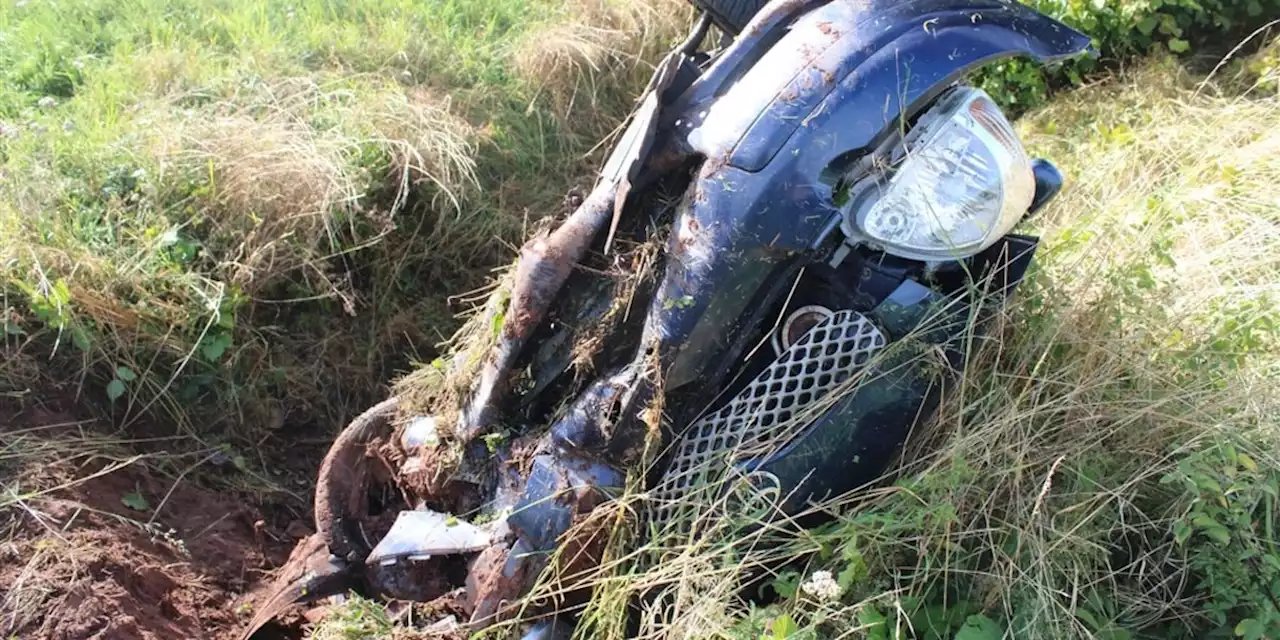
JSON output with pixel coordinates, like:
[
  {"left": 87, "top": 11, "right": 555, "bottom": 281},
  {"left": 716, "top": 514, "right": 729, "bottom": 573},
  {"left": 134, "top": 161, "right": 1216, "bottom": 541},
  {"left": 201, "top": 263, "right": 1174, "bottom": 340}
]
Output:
[{"left": 246, "top": 0, "right": 1089, "bottom": 637}]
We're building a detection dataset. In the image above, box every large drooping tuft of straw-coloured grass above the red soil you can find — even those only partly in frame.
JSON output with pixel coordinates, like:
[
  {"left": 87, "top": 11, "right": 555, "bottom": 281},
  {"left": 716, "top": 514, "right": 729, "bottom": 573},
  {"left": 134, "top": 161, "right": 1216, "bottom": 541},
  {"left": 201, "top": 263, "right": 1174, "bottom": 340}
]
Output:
[{"left": 173, "top": 78, "right": 476, "bottom": 294}]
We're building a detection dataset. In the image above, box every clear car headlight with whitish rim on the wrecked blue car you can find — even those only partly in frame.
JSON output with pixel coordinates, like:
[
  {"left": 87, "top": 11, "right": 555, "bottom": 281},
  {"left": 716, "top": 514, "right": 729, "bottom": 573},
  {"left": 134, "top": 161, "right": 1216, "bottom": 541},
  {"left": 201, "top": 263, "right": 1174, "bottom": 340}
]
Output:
[{"left": 845, "top": 87, "right": 1036, "bottom": 260}]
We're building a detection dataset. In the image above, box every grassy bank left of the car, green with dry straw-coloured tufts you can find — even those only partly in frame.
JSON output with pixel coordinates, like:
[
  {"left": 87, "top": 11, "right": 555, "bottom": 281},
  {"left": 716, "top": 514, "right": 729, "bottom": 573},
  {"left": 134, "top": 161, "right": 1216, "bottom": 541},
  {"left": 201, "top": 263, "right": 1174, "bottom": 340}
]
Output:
[{"left": 0, "top": 0, "right": 689, "bottom": 439}]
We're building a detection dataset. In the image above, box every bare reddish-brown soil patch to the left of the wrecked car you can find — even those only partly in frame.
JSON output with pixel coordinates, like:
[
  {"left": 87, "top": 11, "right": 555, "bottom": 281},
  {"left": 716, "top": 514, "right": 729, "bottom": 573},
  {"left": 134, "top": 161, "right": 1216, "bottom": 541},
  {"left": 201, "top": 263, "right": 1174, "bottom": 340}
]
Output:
[{"left": 0, "top": 398, "right": 311, "bottom": 640}]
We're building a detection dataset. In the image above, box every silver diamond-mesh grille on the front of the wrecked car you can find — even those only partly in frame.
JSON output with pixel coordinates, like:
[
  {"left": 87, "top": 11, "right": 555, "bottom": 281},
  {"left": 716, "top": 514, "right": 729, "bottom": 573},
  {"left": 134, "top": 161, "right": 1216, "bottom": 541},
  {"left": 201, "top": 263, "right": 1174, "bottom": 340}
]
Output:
[{"left": 650, "top": 310, "right": 886, "bottom": 532}]
